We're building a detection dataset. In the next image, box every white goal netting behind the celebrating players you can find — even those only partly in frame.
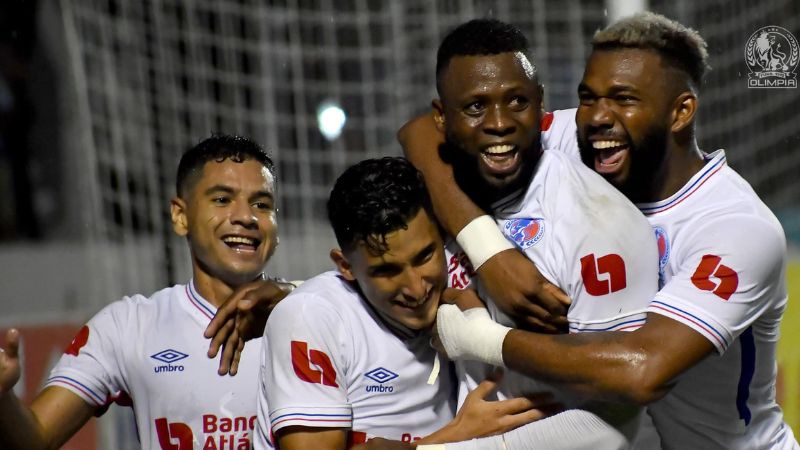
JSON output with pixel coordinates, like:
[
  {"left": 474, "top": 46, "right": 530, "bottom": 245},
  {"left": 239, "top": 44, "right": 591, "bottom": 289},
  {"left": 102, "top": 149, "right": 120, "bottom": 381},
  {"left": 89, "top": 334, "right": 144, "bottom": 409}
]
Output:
[{"left": 53, "top": 0, "right": 800, "bottom": 312}]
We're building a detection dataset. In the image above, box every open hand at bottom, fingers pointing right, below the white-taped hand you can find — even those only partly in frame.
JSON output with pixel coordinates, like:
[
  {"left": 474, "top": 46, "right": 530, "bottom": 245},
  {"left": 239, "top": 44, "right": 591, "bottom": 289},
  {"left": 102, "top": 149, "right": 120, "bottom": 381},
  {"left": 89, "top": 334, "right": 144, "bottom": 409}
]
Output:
[{"left": 420, "top": 370, "right": 563, "bottom": 443}]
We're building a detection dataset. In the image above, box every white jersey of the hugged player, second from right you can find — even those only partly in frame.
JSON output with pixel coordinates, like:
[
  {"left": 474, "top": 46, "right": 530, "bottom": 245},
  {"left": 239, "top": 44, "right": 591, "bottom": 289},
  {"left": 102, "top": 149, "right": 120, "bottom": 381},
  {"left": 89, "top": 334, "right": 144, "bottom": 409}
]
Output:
[{"left": 448, "top": 151, "right": 658, "bottom": 436}]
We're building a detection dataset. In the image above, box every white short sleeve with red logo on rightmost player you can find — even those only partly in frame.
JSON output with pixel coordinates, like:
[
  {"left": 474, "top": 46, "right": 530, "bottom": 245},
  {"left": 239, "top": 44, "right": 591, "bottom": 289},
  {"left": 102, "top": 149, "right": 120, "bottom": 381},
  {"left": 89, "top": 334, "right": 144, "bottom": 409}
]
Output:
[{"left": 649, "top": 215, "right": 786, "bottom": 354}]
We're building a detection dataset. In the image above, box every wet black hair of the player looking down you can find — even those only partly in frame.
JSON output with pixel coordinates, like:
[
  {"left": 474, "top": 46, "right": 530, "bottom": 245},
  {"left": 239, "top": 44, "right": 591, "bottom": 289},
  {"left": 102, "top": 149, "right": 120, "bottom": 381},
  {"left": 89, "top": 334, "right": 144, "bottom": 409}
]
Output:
[{"left": 328, "top": 157, "right": 433, "bottom": 254}]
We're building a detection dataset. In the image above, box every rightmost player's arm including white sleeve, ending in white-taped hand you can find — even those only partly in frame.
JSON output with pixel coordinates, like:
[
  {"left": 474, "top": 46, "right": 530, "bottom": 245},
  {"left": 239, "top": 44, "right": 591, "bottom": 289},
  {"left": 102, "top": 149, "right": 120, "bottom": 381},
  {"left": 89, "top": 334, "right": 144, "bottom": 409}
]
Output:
[{"left": 437, "top": 216, "right": 786, "bottom": 404}]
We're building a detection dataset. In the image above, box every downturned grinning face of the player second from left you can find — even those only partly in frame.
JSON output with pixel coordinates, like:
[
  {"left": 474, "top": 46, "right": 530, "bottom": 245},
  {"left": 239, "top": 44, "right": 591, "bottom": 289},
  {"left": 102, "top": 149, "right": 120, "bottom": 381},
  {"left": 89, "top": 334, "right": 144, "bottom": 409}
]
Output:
[{"left": 331, "top": 208, "right": 447, "bottom": 330}]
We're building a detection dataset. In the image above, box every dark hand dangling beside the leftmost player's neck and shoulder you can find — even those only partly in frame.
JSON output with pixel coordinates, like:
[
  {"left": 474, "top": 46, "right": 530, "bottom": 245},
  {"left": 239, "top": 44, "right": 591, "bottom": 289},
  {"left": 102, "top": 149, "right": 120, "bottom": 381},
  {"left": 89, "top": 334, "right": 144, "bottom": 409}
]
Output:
[{"left": 203, "top": 280, "right": 294, "bottom": 375}]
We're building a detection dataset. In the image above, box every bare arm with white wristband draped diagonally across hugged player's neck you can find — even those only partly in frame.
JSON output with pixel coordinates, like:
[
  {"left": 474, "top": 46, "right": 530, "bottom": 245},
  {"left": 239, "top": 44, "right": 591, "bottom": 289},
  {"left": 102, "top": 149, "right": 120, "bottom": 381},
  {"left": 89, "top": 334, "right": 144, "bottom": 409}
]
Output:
[{"left": 398, "top": 113, "right": 569, "bottom": 332}]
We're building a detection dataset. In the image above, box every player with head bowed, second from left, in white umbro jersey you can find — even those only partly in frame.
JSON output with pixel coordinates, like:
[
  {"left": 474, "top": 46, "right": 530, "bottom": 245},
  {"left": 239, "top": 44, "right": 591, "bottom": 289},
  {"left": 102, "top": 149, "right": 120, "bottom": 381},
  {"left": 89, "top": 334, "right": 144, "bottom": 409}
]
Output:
[{"left": 256, "top": 158, "right": 564, "bottom": 450}]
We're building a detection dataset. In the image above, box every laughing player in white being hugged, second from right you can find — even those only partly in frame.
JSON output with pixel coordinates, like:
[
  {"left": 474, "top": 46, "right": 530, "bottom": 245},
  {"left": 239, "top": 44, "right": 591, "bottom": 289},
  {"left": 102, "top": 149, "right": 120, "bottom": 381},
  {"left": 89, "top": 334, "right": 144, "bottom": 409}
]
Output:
[{"left": 400, "top": 20, "right": 658, "bottom": 439}]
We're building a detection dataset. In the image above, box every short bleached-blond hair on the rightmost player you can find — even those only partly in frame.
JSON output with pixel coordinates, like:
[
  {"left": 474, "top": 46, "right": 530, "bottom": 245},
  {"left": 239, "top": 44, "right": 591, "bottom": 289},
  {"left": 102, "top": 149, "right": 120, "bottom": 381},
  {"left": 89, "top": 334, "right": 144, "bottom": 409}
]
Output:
[{"left": 592, "top": 12, "right": 711, "bottom": 88}]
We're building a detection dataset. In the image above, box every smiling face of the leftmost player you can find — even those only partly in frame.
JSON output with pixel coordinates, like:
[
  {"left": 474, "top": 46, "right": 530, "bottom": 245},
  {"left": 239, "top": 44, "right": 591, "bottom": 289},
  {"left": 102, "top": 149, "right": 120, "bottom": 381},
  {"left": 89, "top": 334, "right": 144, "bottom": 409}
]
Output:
[{"left": 171, "top": 159, "right": 278, "bottom": 287}]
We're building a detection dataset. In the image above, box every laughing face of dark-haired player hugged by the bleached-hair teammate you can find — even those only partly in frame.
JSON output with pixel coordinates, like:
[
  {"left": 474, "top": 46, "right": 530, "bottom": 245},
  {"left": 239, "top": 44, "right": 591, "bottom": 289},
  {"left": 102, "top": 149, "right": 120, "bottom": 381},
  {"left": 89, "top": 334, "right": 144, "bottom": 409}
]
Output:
[{"left": 434, "top": 52, "right": 541, "bottom": 197}]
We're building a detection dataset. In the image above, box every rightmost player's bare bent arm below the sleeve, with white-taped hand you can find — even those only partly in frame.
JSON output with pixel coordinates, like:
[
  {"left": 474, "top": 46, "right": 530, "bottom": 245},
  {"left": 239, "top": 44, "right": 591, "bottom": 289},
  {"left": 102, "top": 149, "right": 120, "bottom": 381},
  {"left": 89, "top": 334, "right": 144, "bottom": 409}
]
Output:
[{"left": 437, "top": 305, "right": 714, "bottom": 405}]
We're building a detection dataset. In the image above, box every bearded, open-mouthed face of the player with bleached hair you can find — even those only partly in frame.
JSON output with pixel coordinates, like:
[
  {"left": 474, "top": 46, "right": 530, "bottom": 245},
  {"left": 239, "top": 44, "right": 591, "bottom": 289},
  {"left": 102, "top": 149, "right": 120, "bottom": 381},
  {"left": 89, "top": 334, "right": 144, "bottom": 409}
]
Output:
[{"left": 575, "top": 48, "right": 676, "bottom": 197}]
